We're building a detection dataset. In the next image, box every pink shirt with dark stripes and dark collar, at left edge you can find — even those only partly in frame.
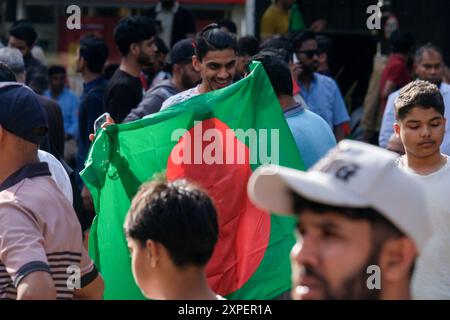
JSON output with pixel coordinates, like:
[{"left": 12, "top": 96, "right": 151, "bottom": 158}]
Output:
[{"left": 0, "top": 163, "right": 98, "bottom": 299}]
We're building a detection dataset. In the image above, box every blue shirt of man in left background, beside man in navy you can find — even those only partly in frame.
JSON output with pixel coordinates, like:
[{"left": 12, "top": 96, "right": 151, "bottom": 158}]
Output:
[{"left": 44, "top": 88, "right": 80, "bottom": 139}]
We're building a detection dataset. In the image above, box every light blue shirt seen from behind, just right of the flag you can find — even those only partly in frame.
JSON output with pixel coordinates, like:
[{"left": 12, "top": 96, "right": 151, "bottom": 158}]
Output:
[{"left": 284, "top": 104, "right": 336, "bottom": 169}]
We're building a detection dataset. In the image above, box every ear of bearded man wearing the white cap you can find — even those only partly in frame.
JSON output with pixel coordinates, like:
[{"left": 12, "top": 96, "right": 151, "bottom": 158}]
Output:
[{"left": 378, "top": 237, "right": 417, "bottom": 283}]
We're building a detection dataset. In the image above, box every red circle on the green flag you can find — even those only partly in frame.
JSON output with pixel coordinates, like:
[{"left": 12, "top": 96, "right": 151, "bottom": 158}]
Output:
[{"left": 167, "top": 118, "right": 270, "bottom": 296}]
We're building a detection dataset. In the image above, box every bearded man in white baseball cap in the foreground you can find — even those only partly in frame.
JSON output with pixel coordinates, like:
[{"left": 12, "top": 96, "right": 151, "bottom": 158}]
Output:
[{"left": 248, "top": 141, "right": 431, "bottom": 300}]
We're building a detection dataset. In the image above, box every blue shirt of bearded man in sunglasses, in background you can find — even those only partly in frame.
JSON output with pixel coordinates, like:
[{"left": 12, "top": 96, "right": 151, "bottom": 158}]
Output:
[{"left": 299, "top": 73, "right": 350, "bottom": 130}]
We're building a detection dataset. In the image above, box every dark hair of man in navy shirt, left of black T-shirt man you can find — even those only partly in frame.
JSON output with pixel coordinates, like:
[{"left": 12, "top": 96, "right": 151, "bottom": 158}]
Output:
[{"left": 80, "top": 35, "right": 109, "bottom": 73}]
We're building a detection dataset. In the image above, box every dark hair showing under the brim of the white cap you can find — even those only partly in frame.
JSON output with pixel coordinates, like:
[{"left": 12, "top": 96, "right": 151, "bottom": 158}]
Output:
[{"left": 292, "top": 192, "right": 406, "bottom": 245}]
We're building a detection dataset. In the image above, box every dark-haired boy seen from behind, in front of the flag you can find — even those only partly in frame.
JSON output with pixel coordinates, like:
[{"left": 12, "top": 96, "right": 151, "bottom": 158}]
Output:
[{"left": 125, "top": 180, "right": 223, "bottom": 300}]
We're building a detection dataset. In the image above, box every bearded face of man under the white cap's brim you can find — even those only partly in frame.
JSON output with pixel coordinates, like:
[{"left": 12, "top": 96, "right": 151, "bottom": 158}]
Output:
[{"left": 292, "top": 210, "right": 380, "bottom": 300}]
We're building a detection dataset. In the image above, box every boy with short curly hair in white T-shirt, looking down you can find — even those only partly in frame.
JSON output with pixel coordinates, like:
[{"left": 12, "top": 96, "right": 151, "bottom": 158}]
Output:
[{"left": 394, "top": 80, "right": 450, "bottom": 299}]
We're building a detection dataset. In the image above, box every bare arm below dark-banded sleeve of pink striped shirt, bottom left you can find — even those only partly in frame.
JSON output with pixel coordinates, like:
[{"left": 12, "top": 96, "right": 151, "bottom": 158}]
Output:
[{"left": 17, "top": 271, "right": 56, "bottom": 300}]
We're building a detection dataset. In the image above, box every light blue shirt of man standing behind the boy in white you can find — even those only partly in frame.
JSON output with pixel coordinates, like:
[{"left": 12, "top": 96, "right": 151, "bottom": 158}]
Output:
[{"left": 378, "top": 83, "right": 450, "bottom": 155}]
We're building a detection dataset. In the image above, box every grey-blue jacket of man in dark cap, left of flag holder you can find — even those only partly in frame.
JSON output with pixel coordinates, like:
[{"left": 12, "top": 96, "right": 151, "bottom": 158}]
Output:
[{"left": 122, "top": 80, "right": 180, "bottom": 123}]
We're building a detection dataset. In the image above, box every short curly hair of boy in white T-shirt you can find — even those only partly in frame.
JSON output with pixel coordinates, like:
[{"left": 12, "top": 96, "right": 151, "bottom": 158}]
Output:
[{"left": 394, "top": 80, "right": 445, "bottom": 120}]
